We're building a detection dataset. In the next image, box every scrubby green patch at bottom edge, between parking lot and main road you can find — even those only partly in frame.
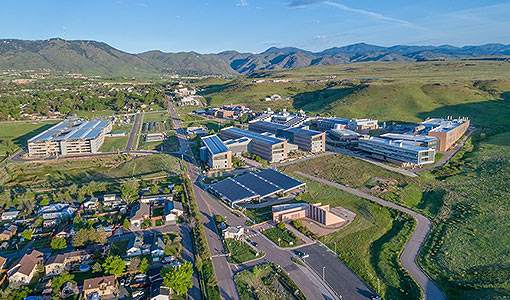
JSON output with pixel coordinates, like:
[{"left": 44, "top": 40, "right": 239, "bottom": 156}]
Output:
[{"left": 234, "top": 264, "right": 306, "bottom": 300}]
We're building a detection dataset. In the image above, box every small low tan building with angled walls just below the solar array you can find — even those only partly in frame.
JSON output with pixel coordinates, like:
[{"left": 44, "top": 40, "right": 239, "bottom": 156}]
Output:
[{"left": 272, "top": 203, "right": 345, "bottom": 226}]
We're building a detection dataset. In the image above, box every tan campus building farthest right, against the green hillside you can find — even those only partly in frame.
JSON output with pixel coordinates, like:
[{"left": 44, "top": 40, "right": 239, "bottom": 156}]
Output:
[{"left": 420, "top": 118, "right": 470, "bottom": 152}]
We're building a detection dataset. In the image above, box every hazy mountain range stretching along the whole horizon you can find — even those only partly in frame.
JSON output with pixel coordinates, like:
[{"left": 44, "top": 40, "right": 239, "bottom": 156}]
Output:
[{"left": 0, "top": 38, "right": 510, "bottom": 77}]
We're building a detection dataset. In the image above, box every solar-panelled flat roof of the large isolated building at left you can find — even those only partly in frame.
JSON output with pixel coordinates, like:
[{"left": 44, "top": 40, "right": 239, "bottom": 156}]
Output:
[{"left": 28, "top": 120, "right": 110, "bottom": 143}]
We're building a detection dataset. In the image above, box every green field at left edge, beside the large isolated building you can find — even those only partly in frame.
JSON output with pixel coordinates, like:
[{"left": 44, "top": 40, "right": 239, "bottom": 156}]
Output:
[{"left": 0, "top": 121, "right": 56, "bottom": 156}]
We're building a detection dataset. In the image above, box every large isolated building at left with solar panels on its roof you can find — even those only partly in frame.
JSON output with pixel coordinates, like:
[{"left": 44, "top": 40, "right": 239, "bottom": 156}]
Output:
[{"left": 28, "top": 120, "right": 112, "bottom": 156}]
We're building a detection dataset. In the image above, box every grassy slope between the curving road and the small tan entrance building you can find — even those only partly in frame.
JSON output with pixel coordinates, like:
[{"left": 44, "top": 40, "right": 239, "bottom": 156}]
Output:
[{"left": 291, "top": 173, "right": 420, "bottom": 299}]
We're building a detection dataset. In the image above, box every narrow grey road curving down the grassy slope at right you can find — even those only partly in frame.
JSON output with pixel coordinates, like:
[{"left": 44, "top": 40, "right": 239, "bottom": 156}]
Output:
[{"left": 295, "top": 171, "right": 446, "bottom": 300}]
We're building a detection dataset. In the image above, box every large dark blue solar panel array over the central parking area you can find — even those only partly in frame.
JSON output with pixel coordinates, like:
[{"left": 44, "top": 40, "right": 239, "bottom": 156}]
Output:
[{"left": 210, "top": 169, "right": 304, "bottom": 203}]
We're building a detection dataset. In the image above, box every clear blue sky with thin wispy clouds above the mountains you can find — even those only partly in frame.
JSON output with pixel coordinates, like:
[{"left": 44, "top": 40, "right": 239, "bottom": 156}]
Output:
[{"left": 0, "top": 0, "right": 510, "bottom": 53}]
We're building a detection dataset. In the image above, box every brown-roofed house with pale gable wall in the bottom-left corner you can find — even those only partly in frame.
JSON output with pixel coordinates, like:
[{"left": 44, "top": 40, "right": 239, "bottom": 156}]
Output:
[{"left": 7, "top": 250, "right": 44, "bottom": 286}]
